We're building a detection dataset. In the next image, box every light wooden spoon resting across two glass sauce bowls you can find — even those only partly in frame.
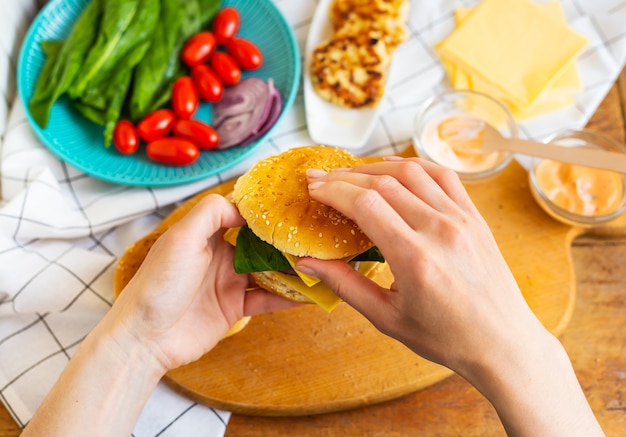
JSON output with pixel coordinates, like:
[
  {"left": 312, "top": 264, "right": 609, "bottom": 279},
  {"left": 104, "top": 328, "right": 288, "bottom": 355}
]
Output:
[{"left": 440, "top": 119, "right": 626, "bottom": 174}]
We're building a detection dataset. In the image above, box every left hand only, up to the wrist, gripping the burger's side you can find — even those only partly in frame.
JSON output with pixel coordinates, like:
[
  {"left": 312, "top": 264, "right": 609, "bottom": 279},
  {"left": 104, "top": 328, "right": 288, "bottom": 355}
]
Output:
[{"left": 107, "top": 195, "right": 295, "bottom": 371}]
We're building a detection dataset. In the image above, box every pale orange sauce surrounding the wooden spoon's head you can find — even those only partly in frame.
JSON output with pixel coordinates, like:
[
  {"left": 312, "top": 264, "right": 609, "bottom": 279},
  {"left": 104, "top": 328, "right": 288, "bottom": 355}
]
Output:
[{"left": 421, "top": 114, "right": 500, "bottom": 173}]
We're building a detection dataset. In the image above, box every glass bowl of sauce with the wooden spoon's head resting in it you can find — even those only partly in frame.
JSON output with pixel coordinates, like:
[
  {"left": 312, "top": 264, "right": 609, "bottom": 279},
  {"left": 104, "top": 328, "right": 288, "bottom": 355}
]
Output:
[{"left": 413, "top": 90, "right": 518, "bottom": 182}]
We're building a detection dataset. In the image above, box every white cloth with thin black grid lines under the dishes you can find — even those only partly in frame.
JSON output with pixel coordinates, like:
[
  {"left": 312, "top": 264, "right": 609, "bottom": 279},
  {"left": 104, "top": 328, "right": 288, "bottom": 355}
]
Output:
[{"left": 0, "top": 0, "right": 626, "bottom": 436}]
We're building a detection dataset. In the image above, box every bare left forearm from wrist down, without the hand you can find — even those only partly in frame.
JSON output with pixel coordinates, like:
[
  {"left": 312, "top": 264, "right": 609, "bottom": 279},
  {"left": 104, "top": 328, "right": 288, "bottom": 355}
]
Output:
[{"left": 22, "top": 316, "right": 163, "bottom": 436}]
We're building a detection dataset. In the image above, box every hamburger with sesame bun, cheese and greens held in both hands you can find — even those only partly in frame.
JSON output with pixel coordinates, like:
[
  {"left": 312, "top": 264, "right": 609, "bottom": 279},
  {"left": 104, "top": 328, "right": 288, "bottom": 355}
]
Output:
[{"left": 224, "top": 146, "right": 384, "bottom": 312}]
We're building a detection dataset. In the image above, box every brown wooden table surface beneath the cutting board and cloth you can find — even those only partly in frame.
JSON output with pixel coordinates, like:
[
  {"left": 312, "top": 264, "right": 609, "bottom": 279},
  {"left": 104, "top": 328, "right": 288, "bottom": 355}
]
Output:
[{"left": 0, "top": 70, "right": 626, "bottom": 437}]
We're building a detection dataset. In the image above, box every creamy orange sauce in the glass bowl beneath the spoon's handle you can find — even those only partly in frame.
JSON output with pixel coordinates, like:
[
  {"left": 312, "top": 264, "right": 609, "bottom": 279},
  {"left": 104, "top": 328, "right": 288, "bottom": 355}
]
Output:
[{"left": 535, "top": 160, "right": 624, "bottom": 216}]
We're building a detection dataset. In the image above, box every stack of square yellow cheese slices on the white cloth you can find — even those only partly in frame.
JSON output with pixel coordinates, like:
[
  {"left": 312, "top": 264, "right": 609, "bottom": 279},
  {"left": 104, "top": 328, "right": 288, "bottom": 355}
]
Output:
[{"left": 436, "top": 0, "right": 587, "bottom": 120}]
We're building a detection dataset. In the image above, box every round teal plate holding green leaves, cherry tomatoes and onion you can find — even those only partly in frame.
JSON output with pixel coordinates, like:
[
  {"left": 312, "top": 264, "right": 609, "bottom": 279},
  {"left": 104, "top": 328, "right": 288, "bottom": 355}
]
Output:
[{"left": 18, "top": 0, "right": 300, "bottom": 186}]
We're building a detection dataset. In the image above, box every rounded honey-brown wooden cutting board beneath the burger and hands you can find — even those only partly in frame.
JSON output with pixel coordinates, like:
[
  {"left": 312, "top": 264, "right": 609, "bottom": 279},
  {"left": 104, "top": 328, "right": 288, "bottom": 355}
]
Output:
[{"left": 115, "top": 153, "right": 579, "bottom": 416}]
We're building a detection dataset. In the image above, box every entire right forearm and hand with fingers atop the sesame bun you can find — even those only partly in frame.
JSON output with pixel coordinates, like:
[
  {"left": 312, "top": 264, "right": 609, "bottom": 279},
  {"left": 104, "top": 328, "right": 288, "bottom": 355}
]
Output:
[{"left": 297, "top": 157, "right": 602, "bottom": 436}]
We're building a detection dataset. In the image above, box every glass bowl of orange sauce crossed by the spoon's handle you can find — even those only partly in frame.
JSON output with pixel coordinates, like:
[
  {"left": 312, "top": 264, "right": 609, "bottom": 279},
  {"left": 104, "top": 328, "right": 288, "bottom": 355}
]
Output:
[{"left": 528, "top": 130, "right": 626, "bottom": 227}]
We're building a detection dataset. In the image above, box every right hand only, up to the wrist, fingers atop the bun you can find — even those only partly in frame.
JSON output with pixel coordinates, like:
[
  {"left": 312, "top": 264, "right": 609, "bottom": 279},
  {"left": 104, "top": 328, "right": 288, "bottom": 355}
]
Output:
[{"left": 297, "top": 158, "right": 545, "bottom": 373}]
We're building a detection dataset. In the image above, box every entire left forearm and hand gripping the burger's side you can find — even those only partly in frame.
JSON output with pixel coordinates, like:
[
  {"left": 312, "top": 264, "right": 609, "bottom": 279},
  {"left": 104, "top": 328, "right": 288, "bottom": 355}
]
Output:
[{"left": 23, "top": 196, "right": 294, "bottom": 436}]
